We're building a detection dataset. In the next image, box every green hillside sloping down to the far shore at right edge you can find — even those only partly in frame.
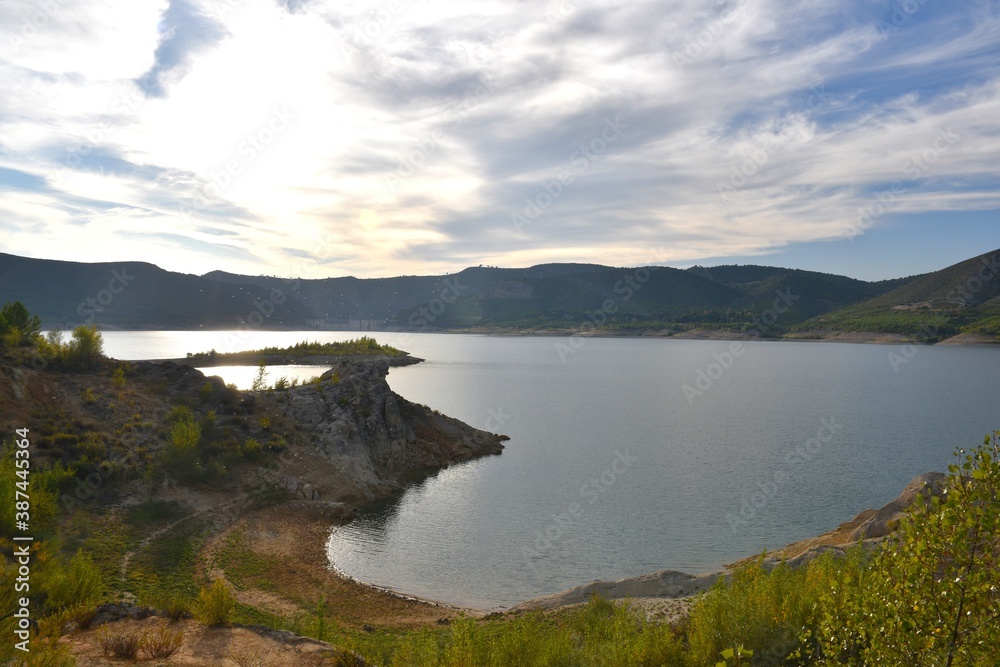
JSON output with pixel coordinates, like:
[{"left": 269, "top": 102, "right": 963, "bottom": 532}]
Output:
[{"left": 802, "top": 250, "right": 1000, "bottom": 341}]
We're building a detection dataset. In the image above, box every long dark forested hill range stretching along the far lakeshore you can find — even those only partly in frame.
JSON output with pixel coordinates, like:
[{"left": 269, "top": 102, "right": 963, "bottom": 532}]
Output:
[{"left": 0, "top": 249, "right": 1000, "bottom": 336}]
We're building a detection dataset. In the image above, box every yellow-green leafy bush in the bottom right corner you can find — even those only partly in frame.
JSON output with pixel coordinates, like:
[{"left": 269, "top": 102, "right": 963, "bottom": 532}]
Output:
[{"left": 819, "top": 434, "right": 1000, "bottom": 667}]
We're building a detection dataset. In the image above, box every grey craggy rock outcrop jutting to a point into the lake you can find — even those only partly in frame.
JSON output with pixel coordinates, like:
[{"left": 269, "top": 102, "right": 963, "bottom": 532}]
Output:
[{"left": 276, "top": 360, "right": 506, "bottom": 500}]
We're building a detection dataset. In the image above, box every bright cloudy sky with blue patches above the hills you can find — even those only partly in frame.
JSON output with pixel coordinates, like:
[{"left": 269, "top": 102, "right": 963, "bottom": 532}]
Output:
[{"left": 0, "top": 0, "right": 1000, "bottom": 280}]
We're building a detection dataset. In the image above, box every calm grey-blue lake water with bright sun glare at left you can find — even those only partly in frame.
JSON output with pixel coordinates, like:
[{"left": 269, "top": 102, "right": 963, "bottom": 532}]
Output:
[{"left": 104, "top": 332, "right": 1000, "bottom": 609}]
